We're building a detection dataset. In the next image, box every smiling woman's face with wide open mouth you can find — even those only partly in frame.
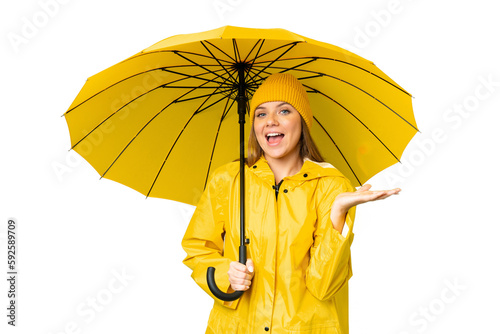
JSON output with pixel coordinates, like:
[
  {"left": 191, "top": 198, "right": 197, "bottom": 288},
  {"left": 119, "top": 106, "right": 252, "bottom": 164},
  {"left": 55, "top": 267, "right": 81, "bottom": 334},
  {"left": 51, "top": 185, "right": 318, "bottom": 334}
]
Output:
[{"left": 253, "top": 102, "right": 302, "bottom": 160}]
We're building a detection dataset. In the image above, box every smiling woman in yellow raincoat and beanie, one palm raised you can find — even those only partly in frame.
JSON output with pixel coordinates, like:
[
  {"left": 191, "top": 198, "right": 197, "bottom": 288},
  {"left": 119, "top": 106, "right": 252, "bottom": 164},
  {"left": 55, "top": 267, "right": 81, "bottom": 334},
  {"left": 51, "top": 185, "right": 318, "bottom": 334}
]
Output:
[{"left": 182, "top": 73, "right": 400, "bottom": 334}]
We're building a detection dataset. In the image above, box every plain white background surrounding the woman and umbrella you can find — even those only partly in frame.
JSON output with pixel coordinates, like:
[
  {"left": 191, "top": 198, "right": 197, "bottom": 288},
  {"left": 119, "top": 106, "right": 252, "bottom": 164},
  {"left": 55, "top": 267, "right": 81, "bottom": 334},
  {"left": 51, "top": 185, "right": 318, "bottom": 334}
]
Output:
[{"left": 0, "top": 0, "right": 500, "bottom": 334}]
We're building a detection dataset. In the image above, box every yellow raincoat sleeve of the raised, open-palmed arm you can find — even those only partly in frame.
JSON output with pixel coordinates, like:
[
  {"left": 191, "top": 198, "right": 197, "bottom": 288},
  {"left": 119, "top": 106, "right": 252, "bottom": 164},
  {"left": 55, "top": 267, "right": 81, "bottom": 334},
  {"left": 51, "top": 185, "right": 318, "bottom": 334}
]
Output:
[{"left": 306, "top": 177, "right": 355, "bottom": 300}]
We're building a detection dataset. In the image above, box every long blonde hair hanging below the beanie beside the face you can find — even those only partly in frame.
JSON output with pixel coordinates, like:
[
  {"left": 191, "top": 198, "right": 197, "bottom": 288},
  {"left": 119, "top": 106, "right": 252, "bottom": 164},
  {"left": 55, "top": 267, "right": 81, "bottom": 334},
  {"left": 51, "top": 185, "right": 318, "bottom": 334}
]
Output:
[{"left": 247, "top": 116, "right": 325, "bottom": 166}]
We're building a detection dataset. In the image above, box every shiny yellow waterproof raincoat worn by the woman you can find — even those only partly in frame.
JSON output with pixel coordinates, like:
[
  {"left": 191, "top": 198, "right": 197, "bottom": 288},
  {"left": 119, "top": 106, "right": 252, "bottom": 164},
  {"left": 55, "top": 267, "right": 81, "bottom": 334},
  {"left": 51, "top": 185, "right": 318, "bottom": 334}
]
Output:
[{"left": 182, "top": 158, "right": 355, "bottom": 334}]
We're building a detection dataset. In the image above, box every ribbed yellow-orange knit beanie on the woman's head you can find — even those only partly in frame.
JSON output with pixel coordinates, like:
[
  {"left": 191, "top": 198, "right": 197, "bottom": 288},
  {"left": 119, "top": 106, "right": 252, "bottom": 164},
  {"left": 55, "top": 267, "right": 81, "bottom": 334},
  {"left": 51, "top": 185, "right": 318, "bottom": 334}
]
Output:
[{"left": 250, "top": 73, "right": 313, "bottom": 130}]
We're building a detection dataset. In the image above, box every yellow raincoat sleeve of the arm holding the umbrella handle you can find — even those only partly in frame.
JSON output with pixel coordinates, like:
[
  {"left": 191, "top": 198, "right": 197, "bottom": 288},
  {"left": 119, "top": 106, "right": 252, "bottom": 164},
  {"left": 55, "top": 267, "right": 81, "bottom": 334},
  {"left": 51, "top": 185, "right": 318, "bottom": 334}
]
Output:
[{"left": 182, "top": 171, "right": 239, "bottom": 309}]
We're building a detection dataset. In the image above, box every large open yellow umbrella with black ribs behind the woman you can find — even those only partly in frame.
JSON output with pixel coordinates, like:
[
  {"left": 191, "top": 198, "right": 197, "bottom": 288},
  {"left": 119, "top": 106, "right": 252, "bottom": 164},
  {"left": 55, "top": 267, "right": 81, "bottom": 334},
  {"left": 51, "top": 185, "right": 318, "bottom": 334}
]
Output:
[{"left": 64, "top": 26, "right": 418, "bottom": 302}]
